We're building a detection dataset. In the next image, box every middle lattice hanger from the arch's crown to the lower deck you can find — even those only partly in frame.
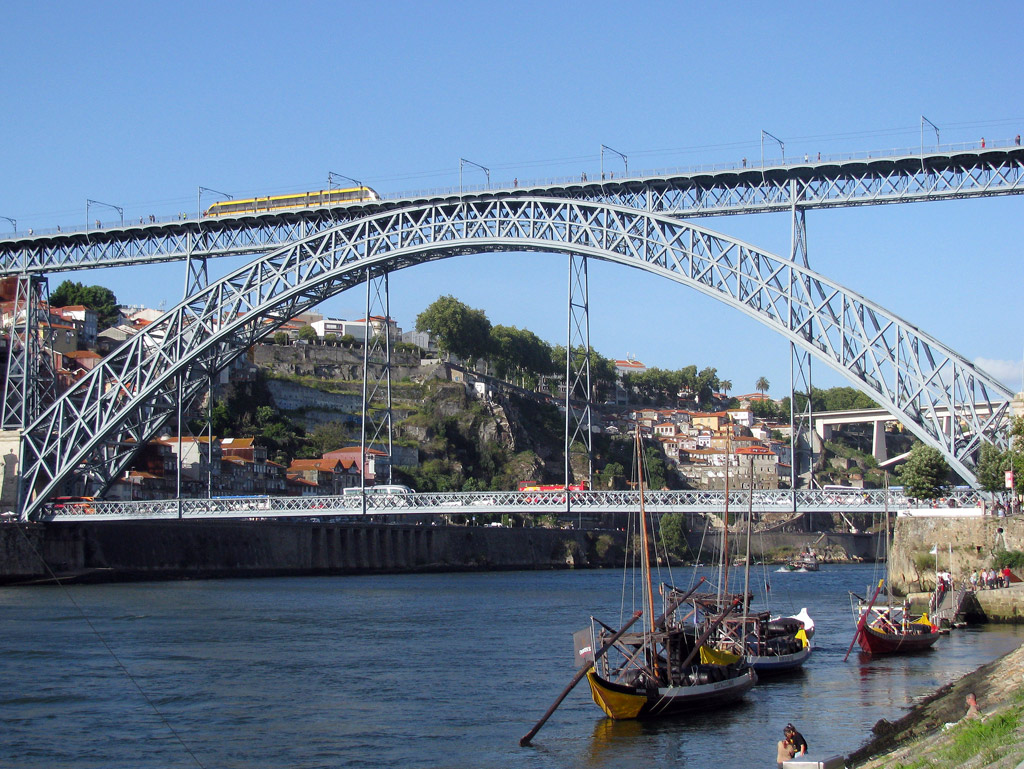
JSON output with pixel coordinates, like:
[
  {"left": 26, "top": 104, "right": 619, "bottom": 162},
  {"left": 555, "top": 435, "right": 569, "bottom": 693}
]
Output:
[{"left": 565, "top": 254, "right": 594, "bottom": 488}]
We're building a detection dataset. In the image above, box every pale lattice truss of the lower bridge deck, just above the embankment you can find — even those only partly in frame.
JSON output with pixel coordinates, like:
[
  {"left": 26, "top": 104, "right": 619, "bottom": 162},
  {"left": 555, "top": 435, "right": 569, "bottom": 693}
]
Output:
[{"left": 39, "top": 488, "right": 982, "bottom": 522}]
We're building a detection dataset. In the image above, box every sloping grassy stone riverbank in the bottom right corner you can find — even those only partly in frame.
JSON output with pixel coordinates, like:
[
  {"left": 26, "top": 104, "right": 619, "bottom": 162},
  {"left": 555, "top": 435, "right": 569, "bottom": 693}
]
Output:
[{"left": 847, "top": 645, "right": 1024, "bottom": 769}]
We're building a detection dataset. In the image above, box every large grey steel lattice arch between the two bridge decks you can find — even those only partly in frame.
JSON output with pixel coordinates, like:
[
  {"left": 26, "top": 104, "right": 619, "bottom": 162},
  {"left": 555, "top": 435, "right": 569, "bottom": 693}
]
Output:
[{"left": 22, "top": 194, "right": 1011, "bottom": 517}]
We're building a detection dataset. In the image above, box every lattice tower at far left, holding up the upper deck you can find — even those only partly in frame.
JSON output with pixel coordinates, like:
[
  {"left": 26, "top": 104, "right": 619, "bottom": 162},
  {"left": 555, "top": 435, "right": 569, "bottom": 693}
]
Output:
[{"left": 0, "top": 274, "right": 56, "bottom": 430}]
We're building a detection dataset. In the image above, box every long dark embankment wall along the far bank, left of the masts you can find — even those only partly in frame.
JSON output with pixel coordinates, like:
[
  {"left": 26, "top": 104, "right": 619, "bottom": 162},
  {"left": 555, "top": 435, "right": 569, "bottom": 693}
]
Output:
[{"left": 0, "top": 521, "right": 624, "bottom": 585}]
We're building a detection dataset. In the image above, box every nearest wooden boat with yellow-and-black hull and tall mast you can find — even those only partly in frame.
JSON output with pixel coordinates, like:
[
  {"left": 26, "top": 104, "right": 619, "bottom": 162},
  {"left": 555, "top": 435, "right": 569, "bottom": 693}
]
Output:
[{"left": 575, "top": 430, "right": 758, "bottom": 719}]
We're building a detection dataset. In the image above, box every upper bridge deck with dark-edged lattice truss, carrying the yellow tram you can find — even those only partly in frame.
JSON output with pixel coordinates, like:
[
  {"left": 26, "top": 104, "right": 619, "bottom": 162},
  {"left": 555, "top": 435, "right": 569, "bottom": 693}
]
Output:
[{"left": 0, "top": 147, "right": 1024, "bottom": 275}]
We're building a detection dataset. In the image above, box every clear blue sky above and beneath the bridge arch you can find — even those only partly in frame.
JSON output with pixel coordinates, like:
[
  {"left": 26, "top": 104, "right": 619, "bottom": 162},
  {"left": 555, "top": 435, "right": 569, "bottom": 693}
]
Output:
[{"left": 0, "top": 1, "right": 1024, "bottom": 396}]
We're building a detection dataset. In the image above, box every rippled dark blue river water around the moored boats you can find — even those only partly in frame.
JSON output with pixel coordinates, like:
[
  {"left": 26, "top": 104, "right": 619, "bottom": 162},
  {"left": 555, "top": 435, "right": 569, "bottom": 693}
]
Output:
[{"left": 0, "top": 565, "right": 1024, "bottom": 769}]
